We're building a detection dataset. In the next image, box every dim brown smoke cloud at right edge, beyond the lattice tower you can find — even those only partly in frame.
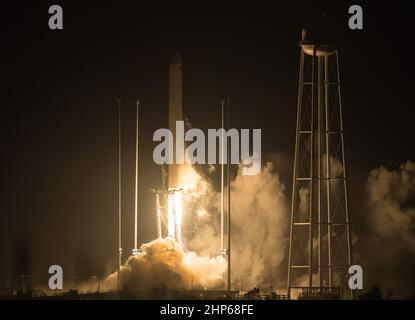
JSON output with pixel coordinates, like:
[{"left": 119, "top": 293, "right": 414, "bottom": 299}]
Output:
[{"left": 367, "top": 161, "right": 415, "bottom": 253}]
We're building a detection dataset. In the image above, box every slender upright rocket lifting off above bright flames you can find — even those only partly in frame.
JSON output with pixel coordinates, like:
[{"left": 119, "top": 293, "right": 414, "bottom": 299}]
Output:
[{"left": 168, "top": 51, "right": 184, "bottom": 189}]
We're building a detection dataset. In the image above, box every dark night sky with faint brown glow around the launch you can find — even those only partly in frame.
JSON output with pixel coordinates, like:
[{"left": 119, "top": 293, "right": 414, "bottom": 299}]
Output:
[{"left": 0, "top": 1, "right": 415, "bottom": 292}]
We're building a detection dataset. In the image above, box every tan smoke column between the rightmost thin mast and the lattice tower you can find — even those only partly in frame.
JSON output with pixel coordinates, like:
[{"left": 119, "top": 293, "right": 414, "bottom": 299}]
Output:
[{"left": 231, "top": 163, "right": 289, "bottom": 288}]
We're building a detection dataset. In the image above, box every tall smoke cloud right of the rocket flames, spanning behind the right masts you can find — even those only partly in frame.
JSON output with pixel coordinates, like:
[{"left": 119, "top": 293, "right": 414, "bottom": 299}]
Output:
[{"left": 183, "top": 163, "right": 289, "bottom": 290}]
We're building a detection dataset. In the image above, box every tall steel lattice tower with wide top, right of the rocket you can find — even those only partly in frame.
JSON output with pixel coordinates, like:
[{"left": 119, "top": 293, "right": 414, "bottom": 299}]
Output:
[{"left": 287, "top": 31, "right": 352, "bottom": 297}]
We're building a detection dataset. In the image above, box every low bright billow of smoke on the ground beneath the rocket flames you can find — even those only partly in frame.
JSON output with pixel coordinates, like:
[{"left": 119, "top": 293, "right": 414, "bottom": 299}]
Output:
[{"left": 92, "top": 238, "right": 226, "bottom": 291}]
